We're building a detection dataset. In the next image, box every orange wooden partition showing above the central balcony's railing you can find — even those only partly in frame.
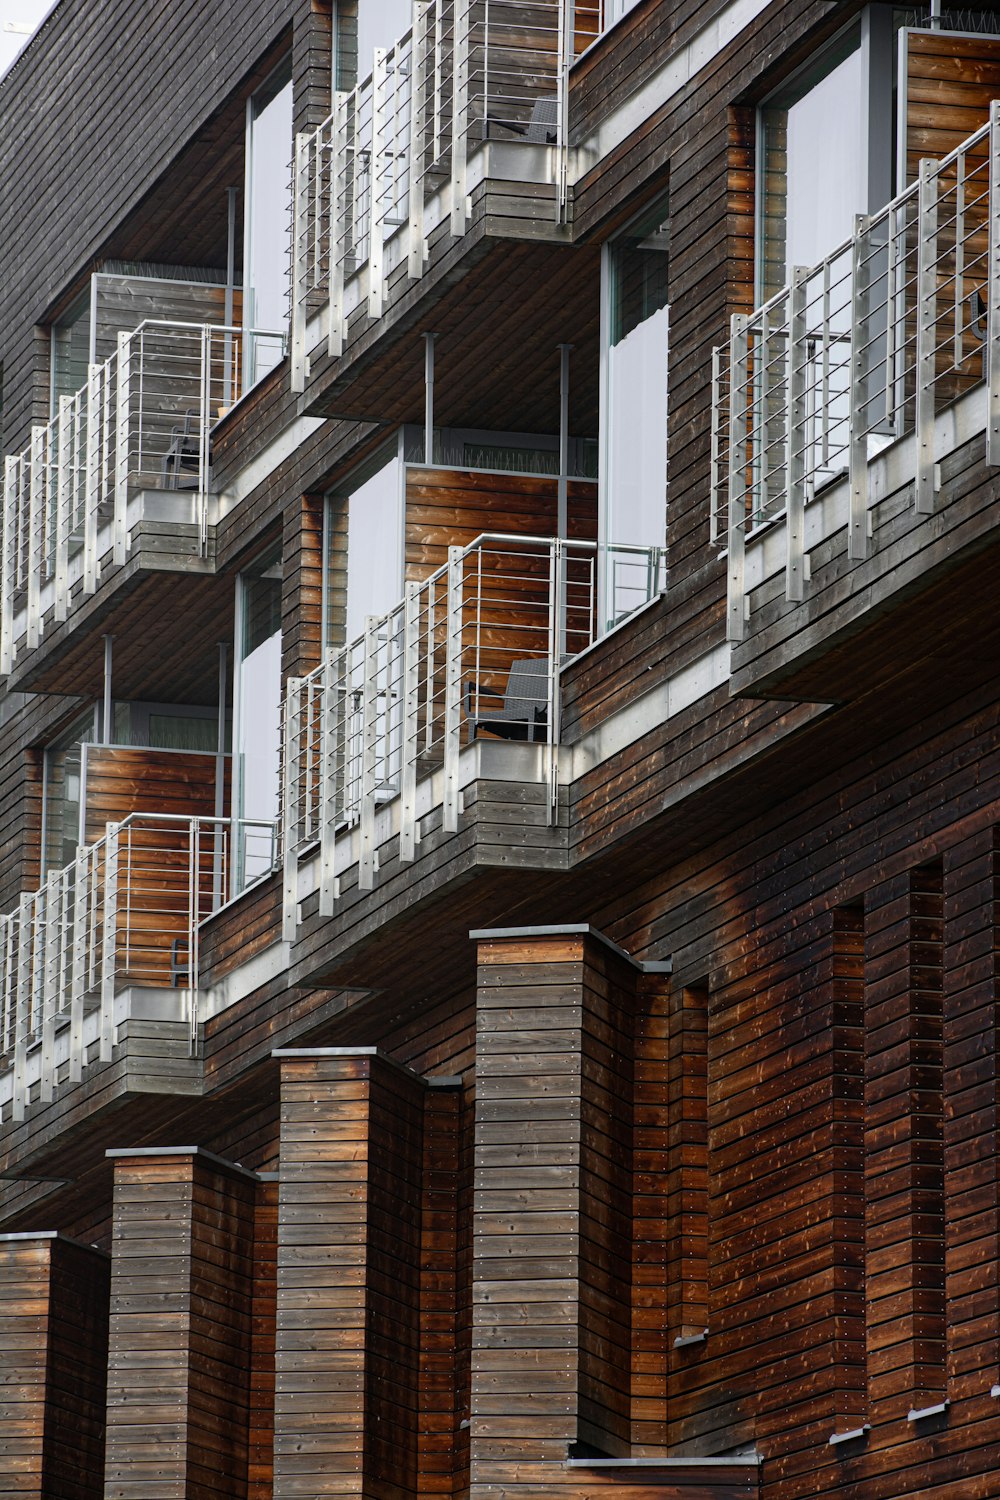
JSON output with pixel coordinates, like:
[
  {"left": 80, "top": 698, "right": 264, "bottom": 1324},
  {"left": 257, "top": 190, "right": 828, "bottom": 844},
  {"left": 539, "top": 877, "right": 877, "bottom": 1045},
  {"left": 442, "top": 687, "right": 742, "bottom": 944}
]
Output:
[{"left": 405, "top": 465, "right": 597, "bottom": 581}]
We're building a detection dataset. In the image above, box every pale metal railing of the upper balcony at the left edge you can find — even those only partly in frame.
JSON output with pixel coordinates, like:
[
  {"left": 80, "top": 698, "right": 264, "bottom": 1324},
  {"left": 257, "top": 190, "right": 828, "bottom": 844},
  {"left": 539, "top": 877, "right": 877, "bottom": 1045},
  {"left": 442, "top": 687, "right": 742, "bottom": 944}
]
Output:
[{"left": 0, "top": 320, "right": 283, "bottom": 672}]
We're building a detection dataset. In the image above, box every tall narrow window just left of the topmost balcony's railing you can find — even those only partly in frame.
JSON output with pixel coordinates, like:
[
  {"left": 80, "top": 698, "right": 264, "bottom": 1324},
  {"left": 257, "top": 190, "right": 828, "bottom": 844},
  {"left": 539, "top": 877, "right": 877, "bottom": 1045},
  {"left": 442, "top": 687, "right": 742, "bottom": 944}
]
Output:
[{"left": 243, "top": 59, "right": 292, "bottom": 390}]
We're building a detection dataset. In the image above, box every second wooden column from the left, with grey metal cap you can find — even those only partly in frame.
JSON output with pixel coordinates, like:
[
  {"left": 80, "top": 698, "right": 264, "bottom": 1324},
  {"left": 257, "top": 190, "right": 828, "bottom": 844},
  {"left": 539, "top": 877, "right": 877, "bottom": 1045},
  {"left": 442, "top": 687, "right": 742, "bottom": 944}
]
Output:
[{"left": 105, "top": 1146, "right": 258, "bottom": 1500}]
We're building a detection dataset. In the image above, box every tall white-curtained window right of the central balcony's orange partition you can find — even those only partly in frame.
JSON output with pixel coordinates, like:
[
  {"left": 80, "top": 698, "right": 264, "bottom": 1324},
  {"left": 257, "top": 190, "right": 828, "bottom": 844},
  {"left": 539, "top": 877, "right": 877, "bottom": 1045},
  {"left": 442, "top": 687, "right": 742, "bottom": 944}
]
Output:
[{"left": 598, "top": 195, "right": 670, "bottom": 626}]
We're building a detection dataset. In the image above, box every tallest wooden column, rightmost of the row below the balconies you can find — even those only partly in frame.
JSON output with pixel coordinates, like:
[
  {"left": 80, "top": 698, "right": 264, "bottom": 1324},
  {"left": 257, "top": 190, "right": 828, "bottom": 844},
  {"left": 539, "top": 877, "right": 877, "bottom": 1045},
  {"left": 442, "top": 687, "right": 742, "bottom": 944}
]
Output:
[{"left": 471, "top": 927, "right": 650, "bottom": 1470}]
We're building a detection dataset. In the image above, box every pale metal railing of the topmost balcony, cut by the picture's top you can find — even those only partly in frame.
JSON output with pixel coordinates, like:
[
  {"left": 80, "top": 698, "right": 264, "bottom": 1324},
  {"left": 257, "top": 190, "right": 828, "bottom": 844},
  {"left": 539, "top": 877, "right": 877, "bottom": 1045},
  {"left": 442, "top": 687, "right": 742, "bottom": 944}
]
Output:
[{"left": 291, "top": 0, "right": 604, "bottom": 390}]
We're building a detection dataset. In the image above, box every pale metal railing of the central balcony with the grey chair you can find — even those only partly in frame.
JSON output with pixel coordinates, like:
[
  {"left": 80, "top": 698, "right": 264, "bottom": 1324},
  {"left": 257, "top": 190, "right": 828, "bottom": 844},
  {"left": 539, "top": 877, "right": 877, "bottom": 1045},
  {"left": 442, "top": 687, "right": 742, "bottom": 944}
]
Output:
[{"left": 282, "top": 534, "right": 664, "bottom": 939}]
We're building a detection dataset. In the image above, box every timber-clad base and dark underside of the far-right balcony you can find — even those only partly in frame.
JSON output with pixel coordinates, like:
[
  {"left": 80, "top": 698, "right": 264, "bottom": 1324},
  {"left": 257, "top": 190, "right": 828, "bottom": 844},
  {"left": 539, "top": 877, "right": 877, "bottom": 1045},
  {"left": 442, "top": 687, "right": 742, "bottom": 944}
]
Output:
[{"left": 732, "top": 408, "right": 1000, "bottom": 702}]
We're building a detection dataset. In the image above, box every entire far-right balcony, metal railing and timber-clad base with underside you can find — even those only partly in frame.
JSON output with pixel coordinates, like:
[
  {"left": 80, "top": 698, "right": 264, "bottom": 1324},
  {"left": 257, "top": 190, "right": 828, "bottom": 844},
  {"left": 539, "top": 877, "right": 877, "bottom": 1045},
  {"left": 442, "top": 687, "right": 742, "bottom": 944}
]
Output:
[{"left": 712, "top": 104, "right": 1000, "bottom": 701}]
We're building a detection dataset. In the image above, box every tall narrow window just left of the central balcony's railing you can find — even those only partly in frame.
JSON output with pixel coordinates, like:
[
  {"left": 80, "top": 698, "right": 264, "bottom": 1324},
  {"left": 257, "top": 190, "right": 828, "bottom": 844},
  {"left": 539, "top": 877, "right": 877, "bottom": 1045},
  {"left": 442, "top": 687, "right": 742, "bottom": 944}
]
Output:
[{"left": 232, "top": 552, "right": 282, "bottom": 894}]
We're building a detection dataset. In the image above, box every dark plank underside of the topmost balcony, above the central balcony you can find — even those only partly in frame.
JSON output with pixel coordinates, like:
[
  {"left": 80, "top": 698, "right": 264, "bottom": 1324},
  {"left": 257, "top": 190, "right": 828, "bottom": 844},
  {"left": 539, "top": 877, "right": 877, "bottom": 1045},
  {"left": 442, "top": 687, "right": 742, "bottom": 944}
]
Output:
[{"left": 303, "top": 231, "right": 600, "bottom": 435}]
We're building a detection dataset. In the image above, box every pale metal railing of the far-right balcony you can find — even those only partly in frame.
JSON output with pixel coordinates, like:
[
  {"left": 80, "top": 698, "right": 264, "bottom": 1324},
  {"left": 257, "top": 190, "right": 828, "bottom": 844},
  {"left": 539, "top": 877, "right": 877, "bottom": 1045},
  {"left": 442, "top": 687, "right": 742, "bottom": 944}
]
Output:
[{"left": 711, "top": 104, "right": 1000, "bottom": 641}]
